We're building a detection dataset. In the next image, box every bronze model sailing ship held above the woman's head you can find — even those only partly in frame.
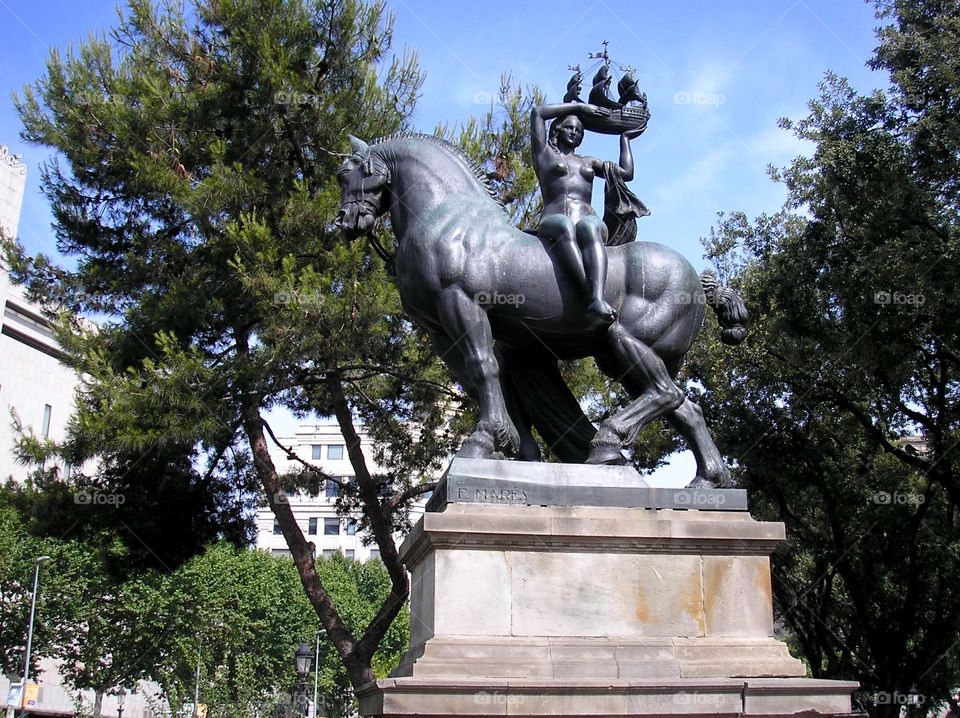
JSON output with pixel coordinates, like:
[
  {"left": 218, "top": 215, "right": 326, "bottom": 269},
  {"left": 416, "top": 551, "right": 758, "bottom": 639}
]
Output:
[{"left": 563, "top": 42, "right": 650, "bottom": 135}]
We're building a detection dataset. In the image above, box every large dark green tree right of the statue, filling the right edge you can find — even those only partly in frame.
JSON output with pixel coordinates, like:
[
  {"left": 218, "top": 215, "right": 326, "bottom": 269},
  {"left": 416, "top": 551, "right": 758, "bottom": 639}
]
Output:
[{"left": 692, "top": 0, "right": 960, "bottom": 716}]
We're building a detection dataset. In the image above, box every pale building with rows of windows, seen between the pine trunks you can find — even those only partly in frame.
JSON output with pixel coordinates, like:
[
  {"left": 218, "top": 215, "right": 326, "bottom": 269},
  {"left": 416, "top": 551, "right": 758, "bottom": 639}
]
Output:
[{"left": 257, "top": 421, "right": 426, "bottom": 561}]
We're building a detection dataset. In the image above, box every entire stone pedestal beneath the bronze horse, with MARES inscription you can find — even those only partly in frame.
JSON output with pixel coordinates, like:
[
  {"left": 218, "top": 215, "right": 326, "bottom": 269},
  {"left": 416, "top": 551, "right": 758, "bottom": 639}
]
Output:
[{"left": 358, "top": 460, "right": 857, "bottom": 716}]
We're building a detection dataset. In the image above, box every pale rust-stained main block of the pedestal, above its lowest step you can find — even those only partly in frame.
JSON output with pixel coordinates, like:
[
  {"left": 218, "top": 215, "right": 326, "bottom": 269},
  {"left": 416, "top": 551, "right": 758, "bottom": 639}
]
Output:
[{"left": 398, "top": 505, "right": 803, "bottom": 678}]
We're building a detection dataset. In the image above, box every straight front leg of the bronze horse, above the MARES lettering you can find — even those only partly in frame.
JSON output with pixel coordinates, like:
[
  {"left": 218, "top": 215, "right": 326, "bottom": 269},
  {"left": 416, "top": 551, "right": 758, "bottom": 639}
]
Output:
[{"left": 439, "top": 288, "right": 520, "bottom": 458}]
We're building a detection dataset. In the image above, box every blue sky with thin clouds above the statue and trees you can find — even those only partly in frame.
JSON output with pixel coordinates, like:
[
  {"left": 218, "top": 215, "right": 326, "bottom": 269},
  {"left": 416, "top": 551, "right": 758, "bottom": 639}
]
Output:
[{"left": 0, "top": 0, "right": 887, "bottom": 484}]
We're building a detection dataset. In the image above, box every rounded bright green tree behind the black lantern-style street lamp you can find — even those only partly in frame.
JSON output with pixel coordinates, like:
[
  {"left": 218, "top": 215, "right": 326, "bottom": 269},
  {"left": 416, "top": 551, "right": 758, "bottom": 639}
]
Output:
[{"left": 149, "top": 543, "right": 316, "bottom": 717}]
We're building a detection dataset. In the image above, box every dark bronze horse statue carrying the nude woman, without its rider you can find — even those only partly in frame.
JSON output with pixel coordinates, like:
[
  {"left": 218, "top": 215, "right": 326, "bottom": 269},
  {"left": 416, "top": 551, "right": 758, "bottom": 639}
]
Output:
[{"left": 335, "top": 133, "right": 747, "bottom": 486}]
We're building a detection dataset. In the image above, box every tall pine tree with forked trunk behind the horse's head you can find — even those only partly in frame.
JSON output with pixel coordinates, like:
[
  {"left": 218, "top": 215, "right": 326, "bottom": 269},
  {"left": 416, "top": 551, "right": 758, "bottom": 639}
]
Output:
[{"left": 2, "top": 0, "right": 438, "bottom": 686}]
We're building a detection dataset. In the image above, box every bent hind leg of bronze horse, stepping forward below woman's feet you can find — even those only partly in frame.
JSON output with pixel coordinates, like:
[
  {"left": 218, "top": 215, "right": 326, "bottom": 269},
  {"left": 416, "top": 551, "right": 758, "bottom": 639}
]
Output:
[{"left": 587, "top": 322, "right": 685, "bottom": 464}]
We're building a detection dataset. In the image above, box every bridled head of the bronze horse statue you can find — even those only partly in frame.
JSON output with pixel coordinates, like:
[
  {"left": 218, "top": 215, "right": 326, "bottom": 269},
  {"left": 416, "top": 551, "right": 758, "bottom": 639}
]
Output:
[{"left": 334, "top": 135, "right": 390, "bottom": 240}]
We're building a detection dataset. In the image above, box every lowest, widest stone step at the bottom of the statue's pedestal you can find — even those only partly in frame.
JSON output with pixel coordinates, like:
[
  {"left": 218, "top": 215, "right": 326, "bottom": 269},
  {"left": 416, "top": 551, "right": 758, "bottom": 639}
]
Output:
[{"left": 357, "top": 678, "right": 858, "bottom": 718}]
